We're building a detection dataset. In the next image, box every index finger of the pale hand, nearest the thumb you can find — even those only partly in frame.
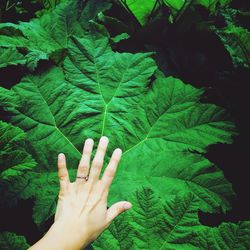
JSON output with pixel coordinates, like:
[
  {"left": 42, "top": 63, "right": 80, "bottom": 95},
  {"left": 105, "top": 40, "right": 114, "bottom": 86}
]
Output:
[{"left": 101, "top": 148, "right": 122, "bottom": 194}]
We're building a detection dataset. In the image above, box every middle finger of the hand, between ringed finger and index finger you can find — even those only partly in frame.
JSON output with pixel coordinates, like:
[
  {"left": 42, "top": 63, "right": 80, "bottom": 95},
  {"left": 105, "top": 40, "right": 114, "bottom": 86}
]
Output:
[{"left": 88, "top": 136, "right": 109, "bottom": 183}]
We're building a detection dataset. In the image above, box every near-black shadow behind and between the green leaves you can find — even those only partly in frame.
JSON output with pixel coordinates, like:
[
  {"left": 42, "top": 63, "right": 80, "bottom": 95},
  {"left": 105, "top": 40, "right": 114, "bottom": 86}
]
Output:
[{"left": 0, "top": 0, "right": 250, "bottom": 244}]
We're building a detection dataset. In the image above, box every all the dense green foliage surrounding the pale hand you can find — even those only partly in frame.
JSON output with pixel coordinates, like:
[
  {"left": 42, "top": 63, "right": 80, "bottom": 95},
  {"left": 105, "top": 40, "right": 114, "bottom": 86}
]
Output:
[{"left": 0, "top": 0, "right": 250, "bottom": 249}]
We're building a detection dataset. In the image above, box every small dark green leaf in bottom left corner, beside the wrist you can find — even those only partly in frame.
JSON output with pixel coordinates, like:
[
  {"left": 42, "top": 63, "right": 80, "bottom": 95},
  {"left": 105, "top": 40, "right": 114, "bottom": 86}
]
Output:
[{"left": 0, "top": 232, "right": 30, "bottom": 250}]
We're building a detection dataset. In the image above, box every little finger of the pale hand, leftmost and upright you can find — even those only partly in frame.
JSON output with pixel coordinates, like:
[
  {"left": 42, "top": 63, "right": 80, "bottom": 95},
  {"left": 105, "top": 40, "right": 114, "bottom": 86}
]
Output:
[{"left": 58, "top": 153, "right": 70, "bottom": 195}]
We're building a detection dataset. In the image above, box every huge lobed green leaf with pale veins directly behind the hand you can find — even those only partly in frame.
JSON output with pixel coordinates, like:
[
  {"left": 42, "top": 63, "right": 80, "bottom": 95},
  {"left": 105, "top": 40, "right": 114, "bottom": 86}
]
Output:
[{"left": 0, "top": 24, "right": 235, "bottom": 224}]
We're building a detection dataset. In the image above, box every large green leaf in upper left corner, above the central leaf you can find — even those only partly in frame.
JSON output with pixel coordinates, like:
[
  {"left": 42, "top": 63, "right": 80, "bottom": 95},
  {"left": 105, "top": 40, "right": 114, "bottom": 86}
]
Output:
[{"left": 0, "top": 0, "right": 110, "bottom": 70}]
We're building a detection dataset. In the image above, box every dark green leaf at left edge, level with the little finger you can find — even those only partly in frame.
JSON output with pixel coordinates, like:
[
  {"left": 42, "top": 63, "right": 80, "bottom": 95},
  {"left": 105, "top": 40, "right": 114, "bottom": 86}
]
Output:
[{"left": 0, "top": 121, "right": 36, "bottom": 207}]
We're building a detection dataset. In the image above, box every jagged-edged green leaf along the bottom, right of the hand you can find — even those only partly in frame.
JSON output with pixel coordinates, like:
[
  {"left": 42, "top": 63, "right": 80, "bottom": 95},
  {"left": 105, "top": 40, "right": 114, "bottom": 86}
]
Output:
[{"left": 92, "top": 187, "right": 250, "bottom": 250}]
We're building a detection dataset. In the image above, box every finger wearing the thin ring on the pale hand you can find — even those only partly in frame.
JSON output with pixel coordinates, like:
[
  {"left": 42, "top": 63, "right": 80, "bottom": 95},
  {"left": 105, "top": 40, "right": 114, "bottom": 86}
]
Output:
[{"left": 76, "top": 138, "right": 94, "bottom": 186}]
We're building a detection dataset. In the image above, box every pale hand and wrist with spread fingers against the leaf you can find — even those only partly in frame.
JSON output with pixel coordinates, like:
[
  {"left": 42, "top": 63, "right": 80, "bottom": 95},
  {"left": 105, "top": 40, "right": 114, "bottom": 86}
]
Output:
[{"left": 29, "top": 136, "right": 132, "bottom": 250}]
